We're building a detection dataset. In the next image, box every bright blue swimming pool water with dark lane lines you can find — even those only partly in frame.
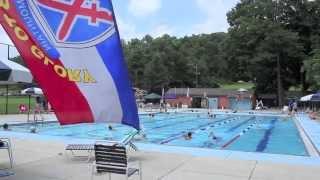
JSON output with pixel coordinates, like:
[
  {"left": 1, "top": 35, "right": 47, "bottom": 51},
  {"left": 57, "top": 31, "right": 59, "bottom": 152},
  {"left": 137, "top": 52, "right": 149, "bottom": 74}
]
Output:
[{"left": 5, "top": 113, "right": 308, "bottom": 156}]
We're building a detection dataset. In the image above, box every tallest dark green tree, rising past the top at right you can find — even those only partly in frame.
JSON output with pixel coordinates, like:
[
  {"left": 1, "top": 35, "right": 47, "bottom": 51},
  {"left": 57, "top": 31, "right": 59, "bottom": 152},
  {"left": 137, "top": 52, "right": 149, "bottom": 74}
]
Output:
[{"left": 226, "top": 0, "right": 320, "bottom": 105}]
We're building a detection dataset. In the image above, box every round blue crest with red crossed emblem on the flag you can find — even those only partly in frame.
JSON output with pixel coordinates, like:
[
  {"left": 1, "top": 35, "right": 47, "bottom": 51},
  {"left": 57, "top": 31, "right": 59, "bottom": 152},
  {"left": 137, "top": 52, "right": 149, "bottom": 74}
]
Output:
[{"left": 29, "top": 0, "right": 115, "bottom": 48}]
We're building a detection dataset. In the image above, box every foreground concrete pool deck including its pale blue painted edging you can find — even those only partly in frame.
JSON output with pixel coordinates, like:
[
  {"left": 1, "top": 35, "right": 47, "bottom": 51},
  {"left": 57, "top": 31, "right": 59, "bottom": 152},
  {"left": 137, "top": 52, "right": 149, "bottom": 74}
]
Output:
[{"left": 0, "top": 114, "right": 320, "bottom": 180}]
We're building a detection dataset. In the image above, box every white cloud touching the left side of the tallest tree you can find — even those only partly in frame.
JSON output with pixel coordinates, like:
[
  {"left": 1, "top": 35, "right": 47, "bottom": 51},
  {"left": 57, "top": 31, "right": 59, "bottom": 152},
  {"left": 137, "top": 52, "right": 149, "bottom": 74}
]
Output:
[{"left": 191, "top": 0, "right": 235, "bottom": 34}]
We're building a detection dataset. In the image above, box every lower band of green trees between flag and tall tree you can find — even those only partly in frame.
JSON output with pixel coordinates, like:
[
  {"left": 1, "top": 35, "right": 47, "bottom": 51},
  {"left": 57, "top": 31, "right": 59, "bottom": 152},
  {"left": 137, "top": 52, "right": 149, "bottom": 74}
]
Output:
[{"left": 123, "top": 33, "right": 227, "bottom": 91}]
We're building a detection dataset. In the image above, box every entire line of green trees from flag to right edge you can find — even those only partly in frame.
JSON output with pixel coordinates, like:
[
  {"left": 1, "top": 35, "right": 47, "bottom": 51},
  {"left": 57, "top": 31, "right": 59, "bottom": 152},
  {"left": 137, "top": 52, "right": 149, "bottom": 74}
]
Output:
[{"left": 123, "top": 0, "right": 320, "bottom": 105}]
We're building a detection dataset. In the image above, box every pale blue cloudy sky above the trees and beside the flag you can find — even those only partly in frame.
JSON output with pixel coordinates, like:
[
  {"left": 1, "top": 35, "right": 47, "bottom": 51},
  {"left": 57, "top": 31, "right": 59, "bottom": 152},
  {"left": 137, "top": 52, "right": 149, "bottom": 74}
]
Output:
[{"left": 0, "top": 0, "right": 239, "bottom": 57}]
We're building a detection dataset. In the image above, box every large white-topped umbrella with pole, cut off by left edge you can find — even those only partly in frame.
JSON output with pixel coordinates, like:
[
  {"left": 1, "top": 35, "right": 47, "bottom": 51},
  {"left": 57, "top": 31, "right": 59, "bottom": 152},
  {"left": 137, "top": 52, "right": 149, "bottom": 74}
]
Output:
[{"left": 0, "top": 60, "right": 32, "bottom": 114}]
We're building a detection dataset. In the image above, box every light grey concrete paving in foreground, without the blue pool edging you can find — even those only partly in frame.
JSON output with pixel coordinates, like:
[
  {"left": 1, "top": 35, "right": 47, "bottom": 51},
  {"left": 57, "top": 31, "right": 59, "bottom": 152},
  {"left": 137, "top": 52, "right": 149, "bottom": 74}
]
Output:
[{"left": 0, "top": 139, "right": 320, "bottom": 180}]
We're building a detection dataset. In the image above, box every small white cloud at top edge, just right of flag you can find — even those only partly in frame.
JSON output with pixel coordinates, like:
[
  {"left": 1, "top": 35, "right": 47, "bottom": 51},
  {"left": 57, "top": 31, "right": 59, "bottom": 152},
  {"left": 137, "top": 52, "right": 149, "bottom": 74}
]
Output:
[{"left": 129, "top": 0, "right": 161, "bottom": 17}]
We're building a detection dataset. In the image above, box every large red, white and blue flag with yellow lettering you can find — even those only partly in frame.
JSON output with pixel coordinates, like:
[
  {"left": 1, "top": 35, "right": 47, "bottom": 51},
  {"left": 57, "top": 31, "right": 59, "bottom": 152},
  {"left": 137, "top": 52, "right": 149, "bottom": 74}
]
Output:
[{"left": 0, "top": 0, "right": 139, "bottom": 129}]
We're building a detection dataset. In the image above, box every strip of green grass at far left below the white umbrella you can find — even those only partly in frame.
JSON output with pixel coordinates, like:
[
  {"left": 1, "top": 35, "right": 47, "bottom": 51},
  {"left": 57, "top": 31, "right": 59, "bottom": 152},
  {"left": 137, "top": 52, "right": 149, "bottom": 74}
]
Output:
[{"left": 0, "top": 96, "right": 35, "bottom": 114}]
